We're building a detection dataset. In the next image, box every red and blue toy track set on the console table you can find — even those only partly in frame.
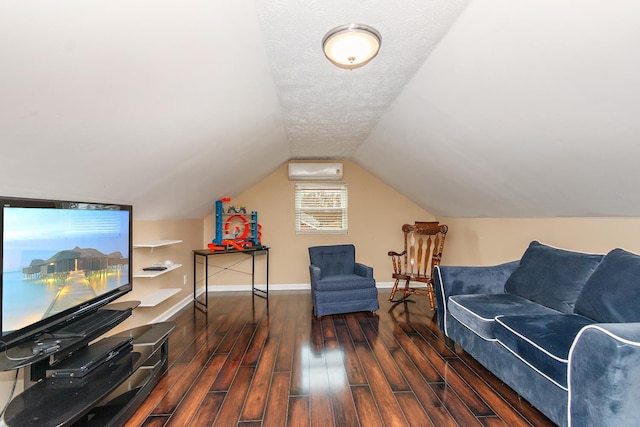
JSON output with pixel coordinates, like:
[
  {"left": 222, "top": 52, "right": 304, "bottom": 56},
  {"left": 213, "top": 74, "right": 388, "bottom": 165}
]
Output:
[{"left": 209, "top": 197, "right": 262, "bottom": 251}]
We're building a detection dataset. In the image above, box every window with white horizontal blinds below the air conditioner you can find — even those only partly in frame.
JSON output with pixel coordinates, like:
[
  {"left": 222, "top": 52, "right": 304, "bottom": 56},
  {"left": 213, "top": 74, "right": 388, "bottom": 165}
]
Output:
[{"left": 295, "top": 182, "right": 348, "bottom": 234}]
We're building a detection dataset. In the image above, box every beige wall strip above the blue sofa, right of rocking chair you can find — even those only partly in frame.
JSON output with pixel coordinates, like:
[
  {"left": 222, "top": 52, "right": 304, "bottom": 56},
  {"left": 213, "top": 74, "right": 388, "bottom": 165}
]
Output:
[{"left": 439, "top": 218, "right": 640, "bottom": 265}]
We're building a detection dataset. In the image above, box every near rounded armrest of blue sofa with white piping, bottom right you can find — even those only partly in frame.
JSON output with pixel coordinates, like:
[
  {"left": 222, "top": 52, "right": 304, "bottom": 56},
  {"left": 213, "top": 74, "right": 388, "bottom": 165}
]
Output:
[{"left": 567, "top": 323, "right": 640, "bottom": 426}]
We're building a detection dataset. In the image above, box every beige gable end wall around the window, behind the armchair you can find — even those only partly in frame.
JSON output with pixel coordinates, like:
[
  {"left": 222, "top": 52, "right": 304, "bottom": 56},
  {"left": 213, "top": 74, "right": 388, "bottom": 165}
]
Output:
[{"left": 203, "top": 161, "right": 434, "bottom": 284}]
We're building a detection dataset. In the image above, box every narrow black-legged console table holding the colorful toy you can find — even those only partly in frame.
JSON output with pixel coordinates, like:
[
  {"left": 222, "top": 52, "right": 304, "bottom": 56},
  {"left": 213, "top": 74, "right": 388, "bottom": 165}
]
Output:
[{"left": 193, "top": 246, "right": 269, "bottom": 311}]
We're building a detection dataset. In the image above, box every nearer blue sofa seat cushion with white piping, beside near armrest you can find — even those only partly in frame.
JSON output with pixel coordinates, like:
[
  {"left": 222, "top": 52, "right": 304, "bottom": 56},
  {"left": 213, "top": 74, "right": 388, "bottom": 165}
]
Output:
[{"left": 494, "top": 313, "right": 594, "bottom": 390}]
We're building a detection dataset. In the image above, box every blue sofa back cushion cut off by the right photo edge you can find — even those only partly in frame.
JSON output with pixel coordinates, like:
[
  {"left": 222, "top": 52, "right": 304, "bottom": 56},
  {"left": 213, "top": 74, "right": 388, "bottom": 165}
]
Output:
[{"left": 575, "top": 249, "right": 640, "bottom": 322}]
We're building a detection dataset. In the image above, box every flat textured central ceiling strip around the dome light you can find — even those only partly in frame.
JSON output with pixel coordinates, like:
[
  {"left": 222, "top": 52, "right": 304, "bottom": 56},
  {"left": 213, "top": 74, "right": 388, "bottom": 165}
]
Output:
[{"left": 252, "top": 0, "right": 466, "bottom": 158}]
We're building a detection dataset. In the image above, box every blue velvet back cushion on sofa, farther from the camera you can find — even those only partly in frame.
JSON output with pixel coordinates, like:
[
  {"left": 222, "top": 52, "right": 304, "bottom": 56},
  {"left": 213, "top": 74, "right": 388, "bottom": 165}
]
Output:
[{"left": 505, "top": 241, "right": 603, "bottom": 313}]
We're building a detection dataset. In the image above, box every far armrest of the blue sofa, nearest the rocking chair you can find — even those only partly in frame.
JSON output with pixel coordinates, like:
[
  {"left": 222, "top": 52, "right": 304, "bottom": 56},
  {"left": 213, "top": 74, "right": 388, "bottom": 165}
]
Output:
[{"left": 433, "top": 260, "right": 520, "bottom": 331}]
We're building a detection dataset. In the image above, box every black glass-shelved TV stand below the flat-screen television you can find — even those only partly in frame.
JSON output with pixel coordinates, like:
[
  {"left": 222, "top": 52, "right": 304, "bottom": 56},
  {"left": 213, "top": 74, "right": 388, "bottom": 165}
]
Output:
[{"left": 0, "top": 302, "right": 175, "bottom": 426}]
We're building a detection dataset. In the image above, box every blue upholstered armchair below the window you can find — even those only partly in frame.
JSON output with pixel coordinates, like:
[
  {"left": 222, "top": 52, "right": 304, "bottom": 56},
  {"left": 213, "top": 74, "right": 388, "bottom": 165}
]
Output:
[{"left": 309, "top": 245, "right": 380, "bottom": 317}]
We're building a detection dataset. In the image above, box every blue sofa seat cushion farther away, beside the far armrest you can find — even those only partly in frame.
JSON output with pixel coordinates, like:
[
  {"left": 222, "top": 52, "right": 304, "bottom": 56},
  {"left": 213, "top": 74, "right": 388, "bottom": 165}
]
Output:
[{"left": 448, "top": 294, "right": 558, "bottom": 341}]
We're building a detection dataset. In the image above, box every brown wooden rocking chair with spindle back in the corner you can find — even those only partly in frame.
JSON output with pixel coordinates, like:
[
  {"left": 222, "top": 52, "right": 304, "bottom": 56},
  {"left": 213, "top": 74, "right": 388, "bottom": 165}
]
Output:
[{"left": 388, "top": 221, "right": 448, "bottom": 310}]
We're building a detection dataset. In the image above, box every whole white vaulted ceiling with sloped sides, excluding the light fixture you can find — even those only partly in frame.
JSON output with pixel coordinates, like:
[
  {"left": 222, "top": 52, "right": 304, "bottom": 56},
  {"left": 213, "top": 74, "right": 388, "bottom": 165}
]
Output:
[{"left": 0, "top": 0, "right": 640, "bottom": 219}]
